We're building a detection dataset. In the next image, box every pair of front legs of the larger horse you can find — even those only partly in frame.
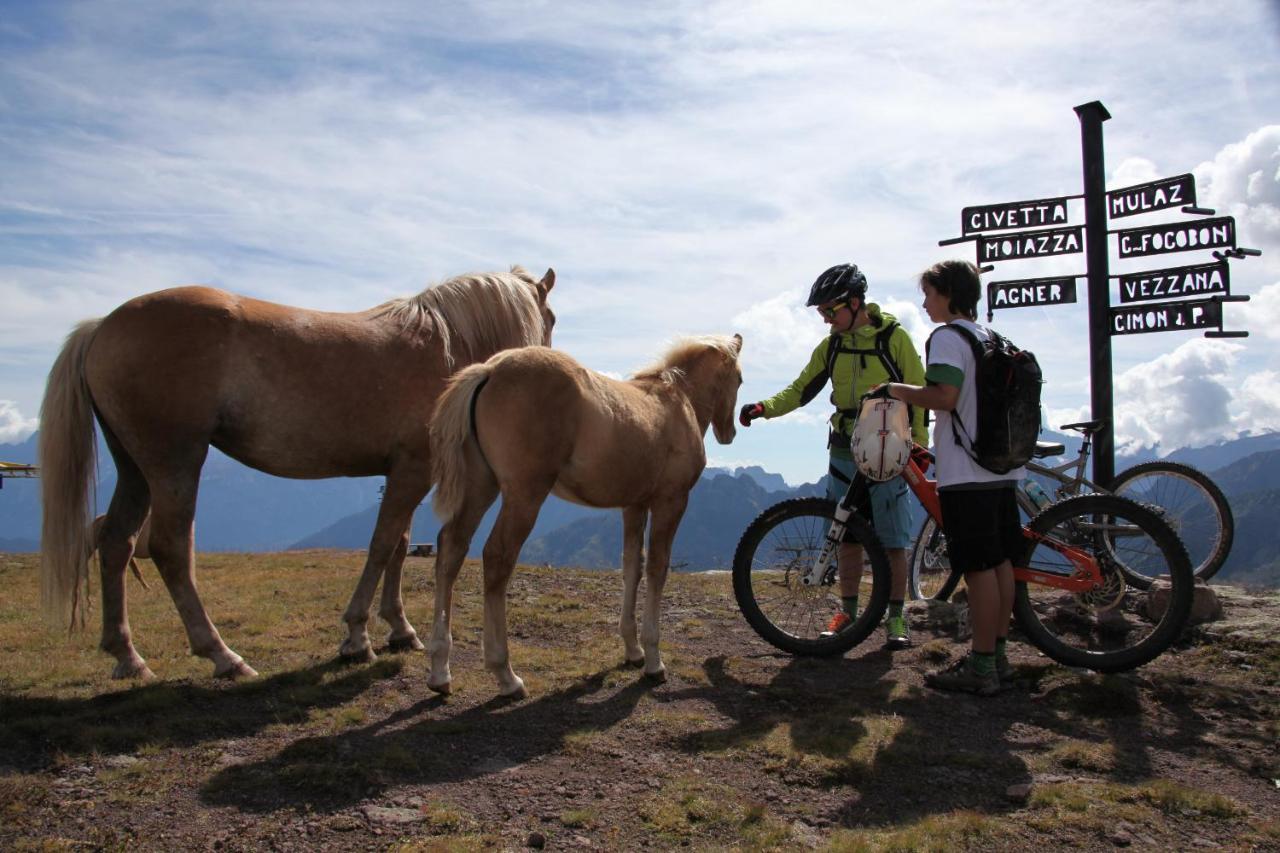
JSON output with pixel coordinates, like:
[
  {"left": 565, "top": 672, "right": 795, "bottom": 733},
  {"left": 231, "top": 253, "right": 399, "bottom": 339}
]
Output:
[{"left": 338, "top": 460, "right": 431, "bottom": 661}]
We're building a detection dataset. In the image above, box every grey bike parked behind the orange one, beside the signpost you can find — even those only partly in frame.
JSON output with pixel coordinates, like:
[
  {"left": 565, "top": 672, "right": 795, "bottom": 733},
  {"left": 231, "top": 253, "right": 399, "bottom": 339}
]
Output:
[{"left": 909, "top": 420, "right": 1235, "bottom": 601}]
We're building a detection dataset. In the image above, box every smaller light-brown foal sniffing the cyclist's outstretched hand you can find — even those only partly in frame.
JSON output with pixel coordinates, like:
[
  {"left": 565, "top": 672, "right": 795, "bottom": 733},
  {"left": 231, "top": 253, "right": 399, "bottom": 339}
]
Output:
[{"left": 428, "top": 336, "right": 742, "bottom": 697}]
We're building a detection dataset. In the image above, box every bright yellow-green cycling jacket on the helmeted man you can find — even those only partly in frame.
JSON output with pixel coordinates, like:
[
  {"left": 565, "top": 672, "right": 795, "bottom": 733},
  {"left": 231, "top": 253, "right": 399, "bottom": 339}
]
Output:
[{"left": 760, "top": 304, "right": 929, "bottom": 447}]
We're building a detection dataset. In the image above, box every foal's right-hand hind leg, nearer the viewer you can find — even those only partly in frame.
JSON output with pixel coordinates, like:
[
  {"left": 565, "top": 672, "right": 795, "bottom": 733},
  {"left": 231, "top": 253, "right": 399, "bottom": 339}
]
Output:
[{"left": 484, "top": 479, "right": 554, "bottom": 698}]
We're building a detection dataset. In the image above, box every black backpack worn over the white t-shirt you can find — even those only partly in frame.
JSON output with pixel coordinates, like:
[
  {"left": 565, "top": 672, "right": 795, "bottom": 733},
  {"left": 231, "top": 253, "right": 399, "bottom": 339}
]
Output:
[{"left": 924, "top": 323, "right": 1044, "bottom": 474}]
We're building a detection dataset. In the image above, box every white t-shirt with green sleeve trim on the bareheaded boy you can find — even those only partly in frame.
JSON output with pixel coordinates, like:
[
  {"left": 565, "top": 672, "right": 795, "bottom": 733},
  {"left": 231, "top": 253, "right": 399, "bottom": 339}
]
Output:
[{"left": 924, "top": 319, "right": 1027, "bottom": 489}]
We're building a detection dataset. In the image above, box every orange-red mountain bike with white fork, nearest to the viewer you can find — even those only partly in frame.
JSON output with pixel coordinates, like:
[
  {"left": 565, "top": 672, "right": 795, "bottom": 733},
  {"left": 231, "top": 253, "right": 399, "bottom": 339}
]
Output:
[{"left": 733, "top": 446, "right": 1196, "bottom": 672}]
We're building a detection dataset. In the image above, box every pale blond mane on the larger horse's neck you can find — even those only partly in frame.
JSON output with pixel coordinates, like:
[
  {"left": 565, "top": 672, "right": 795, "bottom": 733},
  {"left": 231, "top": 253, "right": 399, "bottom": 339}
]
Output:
[{"left": 370, "top": 265, "right": 543, "bottom": 368}]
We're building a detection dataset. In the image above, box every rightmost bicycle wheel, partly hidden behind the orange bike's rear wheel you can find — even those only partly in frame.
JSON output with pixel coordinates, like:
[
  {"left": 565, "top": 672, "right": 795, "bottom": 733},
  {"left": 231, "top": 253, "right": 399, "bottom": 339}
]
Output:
[{"left": 1111, "top": 462, "right": 1235, "bottom": 580}]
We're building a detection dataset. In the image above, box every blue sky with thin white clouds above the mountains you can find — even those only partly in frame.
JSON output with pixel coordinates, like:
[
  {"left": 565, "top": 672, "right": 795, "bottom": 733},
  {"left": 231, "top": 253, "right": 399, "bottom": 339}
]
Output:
[{"left": 0, "top": 0, "right": 1280, "bottom": 482}]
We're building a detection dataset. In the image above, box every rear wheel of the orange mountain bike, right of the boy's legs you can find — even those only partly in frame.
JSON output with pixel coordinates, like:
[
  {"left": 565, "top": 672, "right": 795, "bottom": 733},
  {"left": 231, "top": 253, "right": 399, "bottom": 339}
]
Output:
[{"left": 1014, "top": 494, "right": 1196, "bottom": 672}]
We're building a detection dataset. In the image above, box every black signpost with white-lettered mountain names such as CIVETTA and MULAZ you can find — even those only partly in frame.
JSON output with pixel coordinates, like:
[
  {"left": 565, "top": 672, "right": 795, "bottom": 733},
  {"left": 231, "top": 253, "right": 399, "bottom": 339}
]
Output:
[{"left": 938, "top": 101, "right": 1261, "bottom": 483}]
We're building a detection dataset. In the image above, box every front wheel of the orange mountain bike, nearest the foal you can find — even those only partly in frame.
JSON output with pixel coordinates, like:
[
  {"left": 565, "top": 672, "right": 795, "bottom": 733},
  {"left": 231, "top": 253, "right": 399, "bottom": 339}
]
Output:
[{"left": 733, "top": 498, "right": 890, "bottom": 656}]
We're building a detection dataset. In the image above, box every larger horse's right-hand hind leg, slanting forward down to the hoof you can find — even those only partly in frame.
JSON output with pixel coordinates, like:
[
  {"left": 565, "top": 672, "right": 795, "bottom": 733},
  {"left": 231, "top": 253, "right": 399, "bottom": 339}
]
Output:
[{"left": 146, "top": 465, "right": 257, "bottom": 679}]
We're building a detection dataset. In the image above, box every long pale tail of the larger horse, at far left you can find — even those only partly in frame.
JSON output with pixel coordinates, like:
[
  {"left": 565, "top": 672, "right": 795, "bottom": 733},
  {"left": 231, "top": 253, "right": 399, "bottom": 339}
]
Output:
[{"left": 40, "top": 320, "right": 102, "bottom": 628}]
